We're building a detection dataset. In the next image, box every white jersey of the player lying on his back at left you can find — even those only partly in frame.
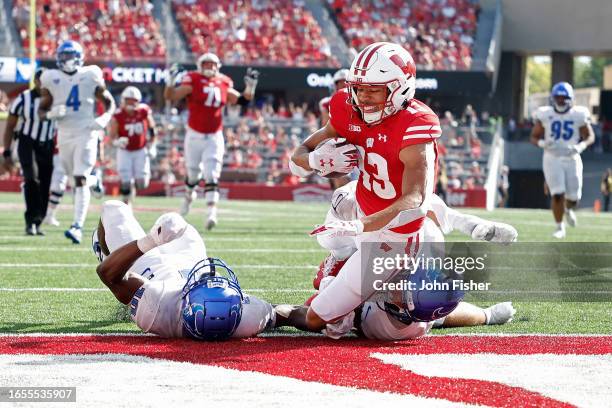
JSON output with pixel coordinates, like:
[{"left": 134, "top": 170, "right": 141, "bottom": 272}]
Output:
[{"left": 129, "top": 251, "right": 275, "bottom": 338}]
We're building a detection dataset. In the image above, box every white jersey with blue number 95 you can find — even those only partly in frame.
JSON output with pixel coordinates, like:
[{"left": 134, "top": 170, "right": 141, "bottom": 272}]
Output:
[{"left": 533, "top": 106, "right": 591, "bottom": 155}]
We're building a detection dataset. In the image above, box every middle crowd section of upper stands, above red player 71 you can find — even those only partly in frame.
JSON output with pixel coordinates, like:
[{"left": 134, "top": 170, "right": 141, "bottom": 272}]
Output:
[{"left": 173, "top": 0, "right": 340, "bottom": 67}]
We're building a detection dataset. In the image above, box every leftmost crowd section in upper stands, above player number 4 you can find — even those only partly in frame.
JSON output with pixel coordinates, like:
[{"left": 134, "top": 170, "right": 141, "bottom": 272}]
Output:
[{"left": 13, "top": 0, "right": 166, "bottom": 61}]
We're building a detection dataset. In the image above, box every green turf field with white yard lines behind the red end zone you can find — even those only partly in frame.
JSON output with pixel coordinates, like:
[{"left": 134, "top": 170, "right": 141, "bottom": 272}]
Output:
[{"left": 0, "top": 193, "right": 612, "bottom": 334}]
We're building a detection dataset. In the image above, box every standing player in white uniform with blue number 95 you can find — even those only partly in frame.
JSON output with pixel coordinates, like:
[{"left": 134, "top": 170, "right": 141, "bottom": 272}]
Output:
[{"left": 531, "top": 82, "right": 595, "bottom": 239}]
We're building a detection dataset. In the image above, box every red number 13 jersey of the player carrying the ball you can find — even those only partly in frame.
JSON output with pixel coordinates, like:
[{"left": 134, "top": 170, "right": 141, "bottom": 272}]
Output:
[{"left": 329, "top": 90, "right": 442, "bottom": 234}]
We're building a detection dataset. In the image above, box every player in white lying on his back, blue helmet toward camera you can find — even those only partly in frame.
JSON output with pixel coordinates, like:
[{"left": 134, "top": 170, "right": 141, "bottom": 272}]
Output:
[{"left": 92, "top": 200, "right": 275, "bottom": 340}]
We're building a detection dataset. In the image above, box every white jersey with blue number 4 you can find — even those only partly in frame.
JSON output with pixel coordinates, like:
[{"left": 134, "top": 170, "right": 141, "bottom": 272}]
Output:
[{"left": 40, "top": 65, "right": 104, "bottom": 138}]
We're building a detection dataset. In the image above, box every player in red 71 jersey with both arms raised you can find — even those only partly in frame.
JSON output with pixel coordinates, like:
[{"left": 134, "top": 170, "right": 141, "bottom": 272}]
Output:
[{"left": 164, "top": 52, "right": 259, "bottom": 229}]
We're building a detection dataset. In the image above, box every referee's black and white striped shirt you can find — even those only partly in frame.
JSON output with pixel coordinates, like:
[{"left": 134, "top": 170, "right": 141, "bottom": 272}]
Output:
[{"left": 9, "top": 89, "right": 55, "bottom": 143}]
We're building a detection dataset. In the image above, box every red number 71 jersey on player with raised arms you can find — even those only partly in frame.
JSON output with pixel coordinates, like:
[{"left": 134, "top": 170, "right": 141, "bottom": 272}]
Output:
[{"left": 181, "top": 71, "right": 234, "bottom": 133}]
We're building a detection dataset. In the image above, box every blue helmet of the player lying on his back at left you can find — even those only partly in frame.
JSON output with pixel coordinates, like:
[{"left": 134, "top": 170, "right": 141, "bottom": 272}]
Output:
[{"left": 181, "top": 258, "right": 244, "bottom": 340}]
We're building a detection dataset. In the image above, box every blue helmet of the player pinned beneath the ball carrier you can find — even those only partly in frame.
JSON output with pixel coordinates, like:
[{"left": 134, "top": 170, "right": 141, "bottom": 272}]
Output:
[{"left": 378, "top": 267, "right": 465, "bottom": 324}]
